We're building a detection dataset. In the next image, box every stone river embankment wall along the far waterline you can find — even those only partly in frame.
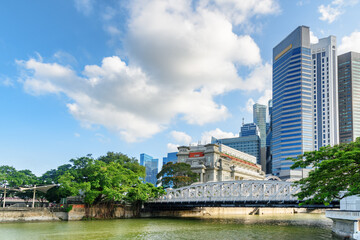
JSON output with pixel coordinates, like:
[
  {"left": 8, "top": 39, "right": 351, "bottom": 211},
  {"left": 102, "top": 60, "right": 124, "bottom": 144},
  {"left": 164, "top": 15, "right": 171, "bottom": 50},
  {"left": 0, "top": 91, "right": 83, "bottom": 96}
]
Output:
[{"left": 0, "top": 204, "right": 332, "bottom": 223}]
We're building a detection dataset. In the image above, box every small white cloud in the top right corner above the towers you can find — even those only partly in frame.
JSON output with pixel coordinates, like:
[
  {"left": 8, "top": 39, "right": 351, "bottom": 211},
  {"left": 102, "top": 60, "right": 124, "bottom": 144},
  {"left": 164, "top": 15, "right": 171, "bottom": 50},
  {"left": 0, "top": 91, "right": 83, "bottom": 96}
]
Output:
[{"left": 318, "top": 0, "right": 358, "bottom": 23}]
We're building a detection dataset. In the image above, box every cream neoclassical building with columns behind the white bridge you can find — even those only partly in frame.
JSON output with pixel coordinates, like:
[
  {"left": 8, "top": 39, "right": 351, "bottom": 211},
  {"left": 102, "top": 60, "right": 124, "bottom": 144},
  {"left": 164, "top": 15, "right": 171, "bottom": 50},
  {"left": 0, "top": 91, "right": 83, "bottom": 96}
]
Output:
[{"left": 177, "top": 144, "right": 265, "bottom": 183}]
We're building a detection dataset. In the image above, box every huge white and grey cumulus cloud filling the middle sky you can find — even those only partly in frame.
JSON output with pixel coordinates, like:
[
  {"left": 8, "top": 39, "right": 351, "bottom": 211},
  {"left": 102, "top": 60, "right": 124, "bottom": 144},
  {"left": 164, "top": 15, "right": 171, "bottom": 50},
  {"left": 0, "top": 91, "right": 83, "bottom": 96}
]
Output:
[{"left": 18, "top": 0, "right": 279, "bottom": 142}]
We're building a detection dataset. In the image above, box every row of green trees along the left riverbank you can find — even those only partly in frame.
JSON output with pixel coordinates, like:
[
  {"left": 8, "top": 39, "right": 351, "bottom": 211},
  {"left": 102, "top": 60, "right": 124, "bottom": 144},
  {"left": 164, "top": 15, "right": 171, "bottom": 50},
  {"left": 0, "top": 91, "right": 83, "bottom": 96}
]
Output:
[{"left": 0, "top": 152, "right": 164, "bottom": 205}]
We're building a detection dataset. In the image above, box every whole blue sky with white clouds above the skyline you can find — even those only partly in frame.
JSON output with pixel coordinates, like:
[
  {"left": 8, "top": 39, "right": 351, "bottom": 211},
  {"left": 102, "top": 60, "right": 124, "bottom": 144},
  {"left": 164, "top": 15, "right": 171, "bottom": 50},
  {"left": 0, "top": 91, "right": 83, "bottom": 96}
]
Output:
[{"left": 0, "top": 0, "right": 360, "bottom": 175}]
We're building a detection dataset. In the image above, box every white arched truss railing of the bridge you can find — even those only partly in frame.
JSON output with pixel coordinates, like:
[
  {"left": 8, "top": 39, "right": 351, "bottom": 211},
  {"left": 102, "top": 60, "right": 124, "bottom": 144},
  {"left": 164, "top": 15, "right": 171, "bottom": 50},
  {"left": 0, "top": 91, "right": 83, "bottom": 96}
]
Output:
[{"left": 150, "top": 180, "right": 300, "bottom": 203}]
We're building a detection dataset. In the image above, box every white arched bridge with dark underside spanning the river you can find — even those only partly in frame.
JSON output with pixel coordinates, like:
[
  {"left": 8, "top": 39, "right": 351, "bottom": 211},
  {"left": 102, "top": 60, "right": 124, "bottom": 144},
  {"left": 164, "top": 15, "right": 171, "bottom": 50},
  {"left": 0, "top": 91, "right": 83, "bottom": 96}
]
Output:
[{"left": 145, "top": 180, "right": 338, "bottom": 209}]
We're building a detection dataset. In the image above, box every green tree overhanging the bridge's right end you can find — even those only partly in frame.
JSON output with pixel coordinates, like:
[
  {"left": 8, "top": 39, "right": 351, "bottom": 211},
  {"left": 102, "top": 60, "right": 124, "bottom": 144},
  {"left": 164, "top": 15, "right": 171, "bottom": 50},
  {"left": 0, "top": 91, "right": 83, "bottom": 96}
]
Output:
[{"left": 291, "top": 138, "right": 360, "bottom": 205}]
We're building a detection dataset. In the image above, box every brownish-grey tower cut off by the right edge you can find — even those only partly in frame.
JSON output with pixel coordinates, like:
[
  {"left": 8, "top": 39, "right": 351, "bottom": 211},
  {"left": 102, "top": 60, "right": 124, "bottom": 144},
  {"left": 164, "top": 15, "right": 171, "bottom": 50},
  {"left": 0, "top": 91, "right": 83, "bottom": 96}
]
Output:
[{"left": 338, "top": 52, "right": 360, "bottom": 143}]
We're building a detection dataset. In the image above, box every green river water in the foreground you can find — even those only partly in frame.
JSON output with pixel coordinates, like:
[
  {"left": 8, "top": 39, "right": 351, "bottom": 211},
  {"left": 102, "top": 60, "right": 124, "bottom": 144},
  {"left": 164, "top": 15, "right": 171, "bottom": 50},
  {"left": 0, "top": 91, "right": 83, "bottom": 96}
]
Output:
[{"left": 0, "top": 214, "right": 335, "bottom": 240}]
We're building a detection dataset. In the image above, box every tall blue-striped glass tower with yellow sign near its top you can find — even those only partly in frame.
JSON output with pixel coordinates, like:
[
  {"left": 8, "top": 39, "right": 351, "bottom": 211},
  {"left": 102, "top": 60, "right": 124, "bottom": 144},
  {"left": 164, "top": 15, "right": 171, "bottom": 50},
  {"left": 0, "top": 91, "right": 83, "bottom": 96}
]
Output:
[{"left": 272, "top": 26, "right": 313, "bottom": 179}]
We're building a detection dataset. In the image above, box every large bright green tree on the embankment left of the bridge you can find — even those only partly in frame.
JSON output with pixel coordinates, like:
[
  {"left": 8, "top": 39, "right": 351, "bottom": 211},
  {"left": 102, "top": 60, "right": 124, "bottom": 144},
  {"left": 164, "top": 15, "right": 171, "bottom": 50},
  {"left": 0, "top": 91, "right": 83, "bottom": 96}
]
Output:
[{"left": 59, "top": 153, "right": 164, "bottom": 205}]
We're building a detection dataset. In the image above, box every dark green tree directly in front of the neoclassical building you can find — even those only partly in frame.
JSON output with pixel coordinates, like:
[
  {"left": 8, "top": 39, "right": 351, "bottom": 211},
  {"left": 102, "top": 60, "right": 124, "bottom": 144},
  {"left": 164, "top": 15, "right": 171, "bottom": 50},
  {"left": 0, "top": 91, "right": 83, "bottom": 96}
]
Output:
[{"left": 156, "top": 162, "right": 198, "bottom": 188}]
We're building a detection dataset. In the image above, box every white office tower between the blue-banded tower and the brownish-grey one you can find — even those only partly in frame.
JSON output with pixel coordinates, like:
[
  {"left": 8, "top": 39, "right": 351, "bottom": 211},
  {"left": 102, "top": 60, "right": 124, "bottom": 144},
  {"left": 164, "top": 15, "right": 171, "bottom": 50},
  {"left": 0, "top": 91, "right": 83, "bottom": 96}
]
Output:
[{"left": 311, "top": 36, "right": 339, "bottom": 150}]
